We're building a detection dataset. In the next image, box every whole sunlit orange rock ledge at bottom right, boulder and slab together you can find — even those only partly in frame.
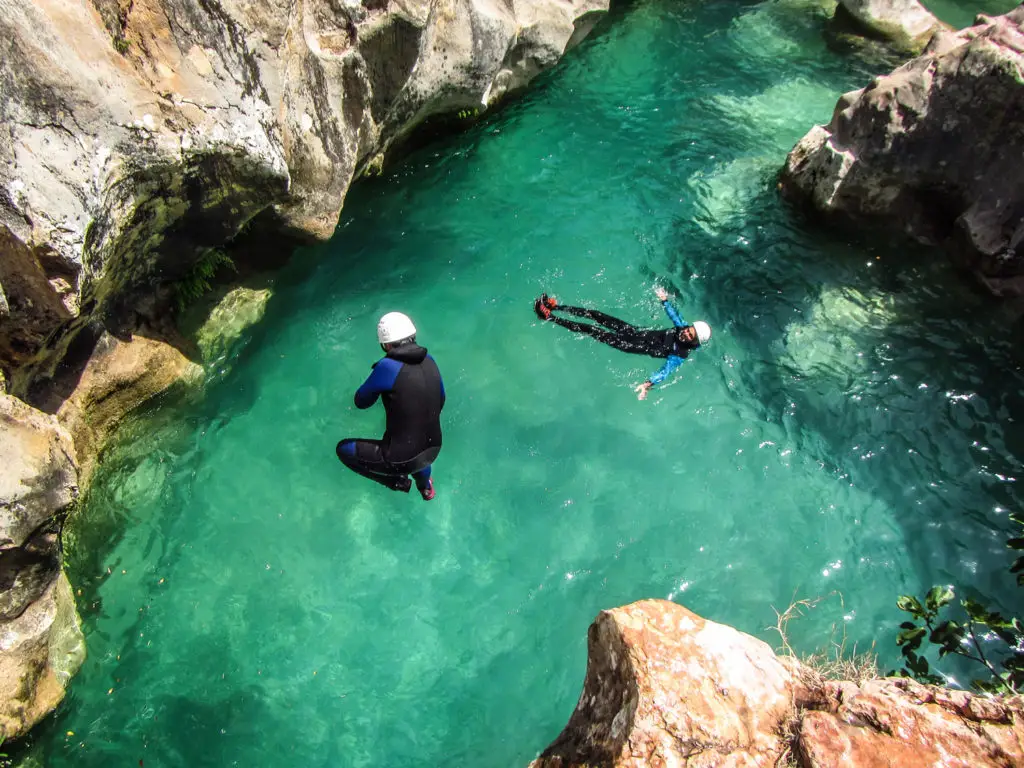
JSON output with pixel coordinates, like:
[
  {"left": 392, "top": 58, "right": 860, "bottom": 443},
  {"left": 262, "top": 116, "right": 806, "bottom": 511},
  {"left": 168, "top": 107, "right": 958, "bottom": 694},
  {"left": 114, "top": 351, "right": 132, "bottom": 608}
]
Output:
[{"left": 529, "top": 600, "right": 1024, "bottom": 768}]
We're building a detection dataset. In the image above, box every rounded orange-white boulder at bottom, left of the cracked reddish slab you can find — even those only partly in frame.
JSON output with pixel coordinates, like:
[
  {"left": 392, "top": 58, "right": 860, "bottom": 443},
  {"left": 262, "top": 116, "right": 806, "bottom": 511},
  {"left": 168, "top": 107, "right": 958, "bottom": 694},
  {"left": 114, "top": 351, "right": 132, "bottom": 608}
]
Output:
[{"left": 530, "top": 600, "right": 803, "bottom": 768}]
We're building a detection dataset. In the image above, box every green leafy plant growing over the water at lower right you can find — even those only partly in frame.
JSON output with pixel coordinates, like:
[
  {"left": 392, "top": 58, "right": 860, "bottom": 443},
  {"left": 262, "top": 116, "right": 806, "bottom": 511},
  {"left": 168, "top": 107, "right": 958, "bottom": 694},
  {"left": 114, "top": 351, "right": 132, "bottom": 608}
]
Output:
[{"left": 890, "top": 513, "right": 1024, "bottom": 693}]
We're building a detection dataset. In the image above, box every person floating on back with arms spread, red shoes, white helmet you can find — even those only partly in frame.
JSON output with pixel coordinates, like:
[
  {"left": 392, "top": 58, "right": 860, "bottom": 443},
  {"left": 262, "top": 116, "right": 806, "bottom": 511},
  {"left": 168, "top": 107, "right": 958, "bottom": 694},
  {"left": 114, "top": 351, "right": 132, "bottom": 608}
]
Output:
[{"left": 534, "top": 288, "right": 711, "bottom": 400}]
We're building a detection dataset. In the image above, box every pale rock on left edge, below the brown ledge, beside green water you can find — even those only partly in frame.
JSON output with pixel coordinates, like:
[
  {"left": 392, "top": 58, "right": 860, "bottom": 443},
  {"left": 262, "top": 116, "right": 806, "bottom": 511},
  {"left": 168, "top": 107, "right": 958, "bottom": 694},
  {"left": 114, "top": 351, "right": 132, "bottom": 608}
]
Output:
[{"left": 0, "top": 394, "right": 84, "bottom": 738}]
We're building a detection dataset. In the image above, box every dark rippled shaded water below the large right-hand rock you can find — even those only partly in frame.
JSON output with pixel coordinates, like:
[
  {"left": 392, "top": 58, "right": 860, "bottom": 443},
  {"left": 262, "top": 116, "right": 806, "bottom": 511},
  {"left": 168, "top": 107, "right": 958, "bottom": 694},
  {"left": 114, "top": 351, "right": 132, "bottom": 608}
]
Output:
[{"left": 667, "top": 179, "right": 1024, "bottom": 626}]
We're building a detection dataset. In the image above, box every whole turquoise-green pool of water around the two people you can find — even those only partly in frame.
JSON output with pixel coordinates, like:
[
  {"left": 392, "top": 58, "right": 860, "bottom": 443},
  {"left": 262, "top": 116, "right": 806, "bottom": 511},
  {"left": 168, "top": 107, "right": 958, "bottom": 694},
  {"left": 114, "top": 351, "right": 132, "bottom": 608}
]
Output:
[{"left": 24, "top": 2, "right": 1024, "bottom": 768}]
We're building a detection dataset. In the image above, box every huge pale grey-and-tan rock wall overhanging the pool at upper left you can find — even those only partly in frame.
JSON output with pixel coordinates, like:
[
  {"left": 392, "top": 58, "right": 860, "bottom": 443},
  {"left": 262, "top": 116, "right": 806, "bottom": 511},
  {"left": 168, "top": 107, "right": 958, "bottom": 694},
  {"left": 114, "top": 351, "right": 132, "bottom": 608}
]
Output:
[{"left": 0, "top": 0, "right": 607, "bottom": 402}]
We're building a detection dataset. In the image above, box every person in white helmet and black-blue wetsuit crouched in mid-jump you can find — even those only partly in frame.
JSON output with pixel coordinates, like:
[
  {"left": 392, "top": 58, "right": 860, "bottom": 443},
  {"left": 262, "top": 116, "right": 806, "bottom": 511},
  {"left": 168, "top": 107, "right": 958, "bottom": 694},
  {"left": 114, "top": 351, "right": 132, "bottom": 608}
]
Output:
[{"left": 337, "top": 312, "right": 444, "bottom": 502}]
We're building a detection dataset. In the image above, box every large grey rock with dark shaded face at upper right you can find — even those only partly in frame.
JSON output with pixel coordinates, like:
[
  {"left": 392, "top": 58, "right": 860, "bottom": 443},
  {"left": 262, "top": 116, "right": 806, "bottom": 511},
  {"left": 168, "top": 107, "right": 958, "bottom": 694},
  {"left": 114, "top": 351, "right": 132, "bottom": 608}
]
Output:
[{"left": 781, "top": 7, "right": 1024, "bottom": 294}]
